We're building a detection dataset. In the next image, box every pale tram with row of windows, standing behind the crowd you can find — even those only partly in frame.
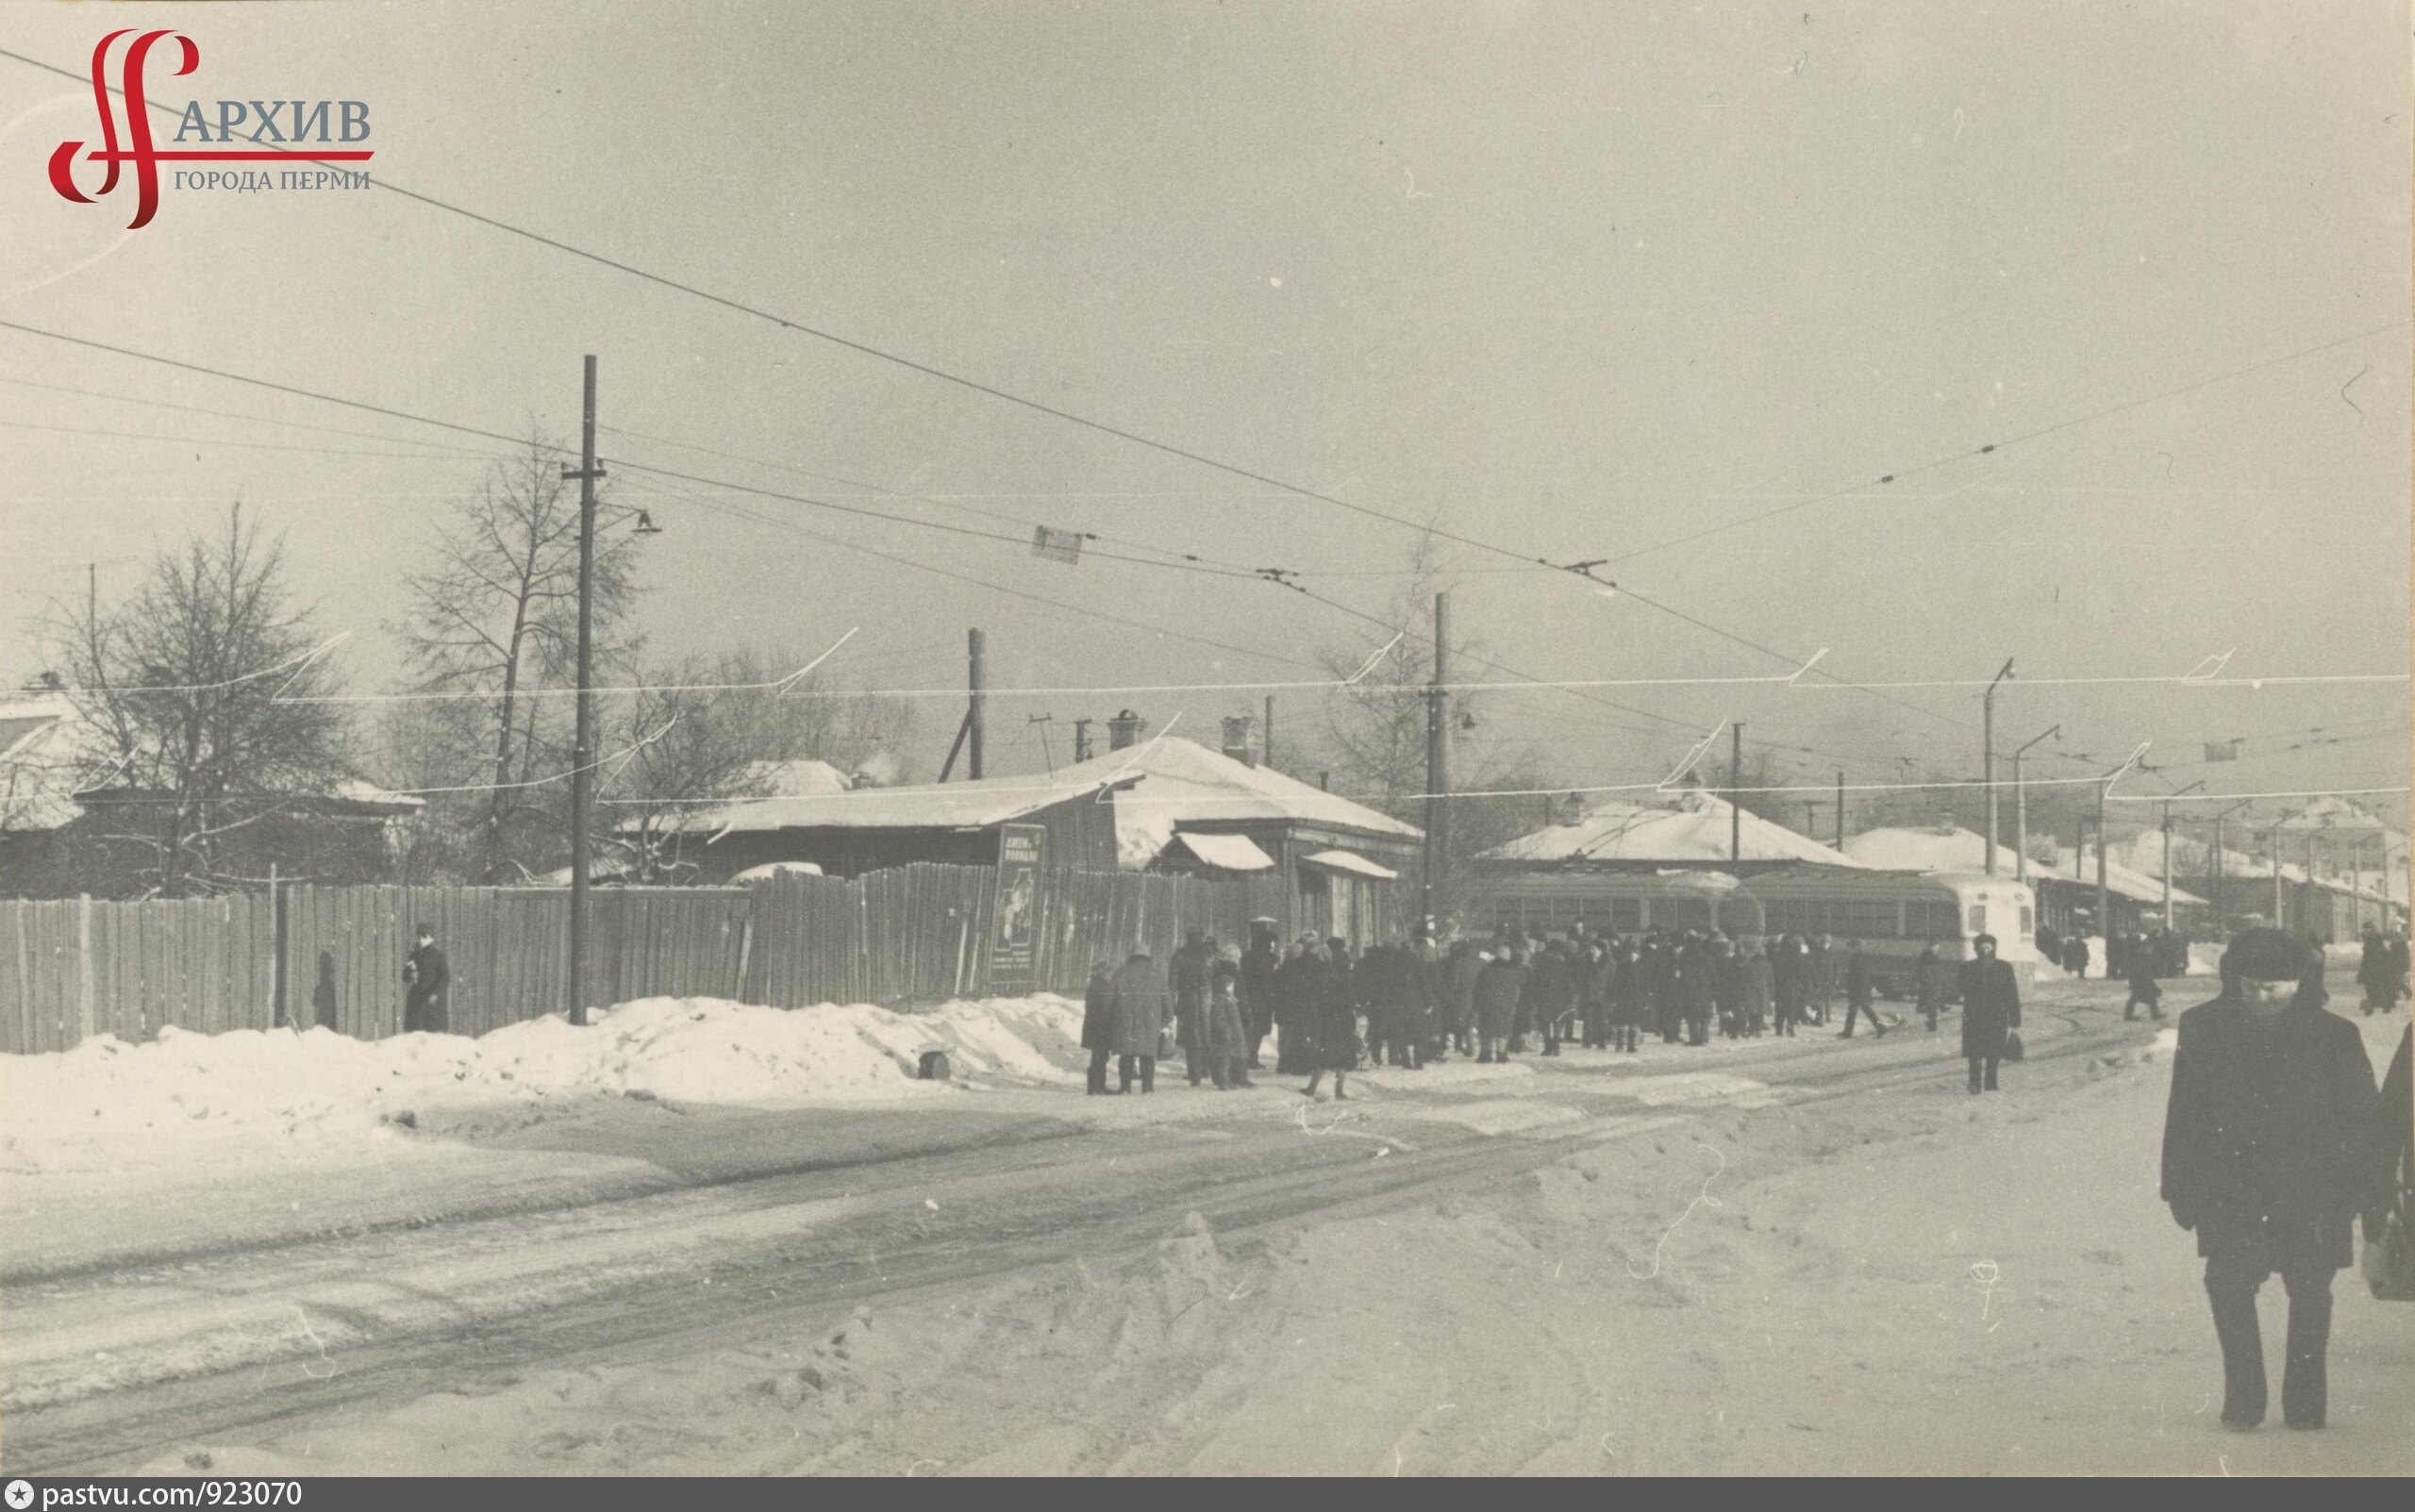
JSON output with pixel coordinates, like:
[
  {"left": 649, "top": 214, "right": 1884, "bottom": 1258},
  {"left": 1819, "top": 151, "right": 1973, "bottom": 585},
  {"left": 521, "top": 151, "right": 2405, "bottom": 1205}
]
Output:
[{"left": 1471, "top": 867, "right": 2039, "bottom": 998}]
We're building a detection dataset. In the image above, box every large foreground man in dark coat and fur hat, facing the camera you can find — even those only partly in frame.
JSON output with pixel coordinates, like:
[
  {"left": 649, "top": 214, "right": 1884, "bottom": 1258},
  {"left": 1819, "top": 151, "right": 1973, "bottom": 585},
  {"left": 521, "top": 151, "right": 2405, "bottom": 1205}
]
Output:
[{"left": 2164, "top": 930, "right": 2379, "bottom": 1430}]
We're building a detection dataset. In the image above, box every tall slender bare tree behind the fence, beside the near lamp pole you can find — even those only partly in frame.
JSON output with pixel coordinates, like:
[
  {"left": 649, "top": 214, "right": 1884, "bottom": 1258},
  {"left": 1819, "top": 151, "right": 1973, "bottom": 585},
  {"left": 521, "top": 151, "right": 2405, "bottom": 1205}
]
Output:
[{"left": 387, "top": 432, "right": 638, "bottom": 882}]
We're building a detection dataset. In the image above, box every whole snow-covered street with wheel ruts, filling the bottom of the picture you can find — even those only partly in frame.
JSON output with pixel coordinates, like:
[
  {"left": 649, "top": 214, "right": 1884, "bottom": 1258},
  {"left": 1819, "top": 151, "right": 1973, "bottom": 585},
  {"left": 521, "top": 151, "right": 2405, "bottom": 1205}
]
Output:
[{"left": 0, "top": 973, "right": 2415, "bottom": 1473}]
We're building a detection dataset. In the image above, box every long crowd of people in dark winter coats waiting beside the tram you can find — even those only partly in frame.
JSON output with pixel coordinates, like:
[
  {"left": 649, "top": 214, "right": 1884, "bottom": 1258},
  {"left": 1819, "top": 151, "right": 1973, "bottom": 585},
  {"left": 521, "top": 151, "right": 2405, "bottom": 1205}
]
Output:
[{"left": 1082, "top": 922, "right": 2022, "bottom": 1099}]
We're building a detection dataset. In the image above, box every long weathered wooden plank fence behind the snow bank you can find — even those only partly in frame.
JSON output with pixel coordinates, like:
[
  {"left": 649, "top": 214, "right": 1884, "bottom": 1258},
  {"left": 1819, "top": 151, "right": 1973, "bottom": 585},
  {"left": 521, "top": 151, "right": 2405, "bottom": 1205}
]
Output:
[{"left": 0, "top": 862, "right": 1282, "bottom": 1053}]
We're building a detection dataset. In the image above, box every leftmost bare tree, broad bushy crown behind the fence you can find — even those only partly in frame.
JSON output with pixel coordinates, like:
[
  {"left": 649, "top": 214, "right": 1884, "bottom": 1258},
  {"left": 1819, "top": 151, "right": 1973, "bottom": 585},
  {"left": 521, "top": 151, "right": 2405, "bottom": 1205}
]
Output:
[{"left": 53, "top": 505, "right": 350, "bottom": 896}]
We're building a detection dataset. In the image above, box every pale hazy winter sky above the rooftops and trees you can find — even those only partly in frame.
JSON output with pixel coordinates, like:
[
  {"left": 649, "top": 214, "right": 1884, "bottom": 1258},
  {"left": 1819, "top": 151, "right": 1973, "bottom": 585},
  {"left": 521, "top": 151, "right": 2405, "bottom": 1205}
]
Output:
[{"left": 0, "top": 0, "right": 2410, "bottom": 811}]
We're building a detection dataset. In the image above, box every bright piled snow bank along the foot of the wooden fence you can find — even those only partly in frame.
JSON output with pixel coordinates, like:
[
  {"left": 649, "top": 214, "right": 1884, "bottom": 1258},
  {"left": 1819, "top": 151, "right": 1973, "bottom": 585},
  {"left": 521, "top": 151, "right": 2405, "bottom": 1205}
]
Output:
[{"left": 0, "top": 995, "right": 1082, "bottom": 1171}]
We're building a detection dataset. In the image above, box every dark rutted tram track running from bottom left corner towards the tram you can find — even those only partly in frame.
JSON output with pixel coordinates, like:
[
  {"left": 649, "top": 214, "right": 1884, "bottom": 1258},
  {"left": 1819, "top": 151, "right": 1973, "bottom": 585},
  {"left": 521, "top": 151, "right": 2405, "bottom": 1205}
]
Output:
[{"left": 0, "top": 975, "right": 2138, "bottom": 1473}]
